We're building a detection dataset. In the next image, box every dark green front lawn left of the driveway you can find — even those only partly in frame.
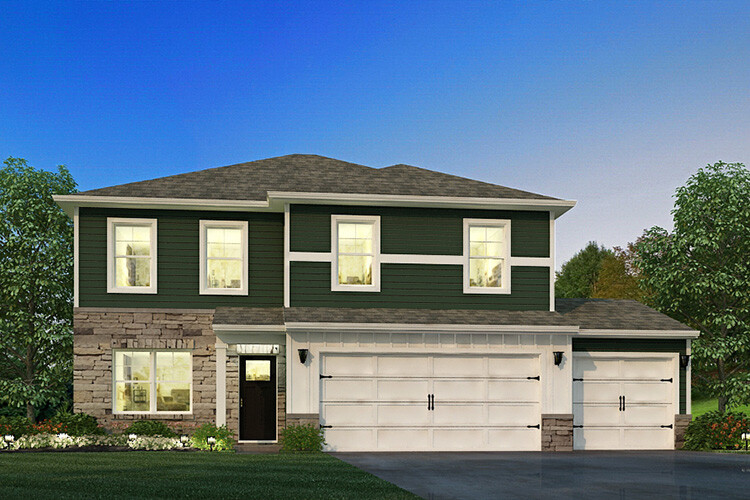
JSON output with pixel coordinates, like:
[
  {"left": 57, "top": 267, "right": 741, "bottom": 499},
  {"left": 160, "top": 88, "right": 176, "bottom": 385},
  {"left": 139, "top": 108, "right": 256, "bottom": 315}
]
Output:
[{"left": 0, "top": 451, "right": 417, "bottom": 500}]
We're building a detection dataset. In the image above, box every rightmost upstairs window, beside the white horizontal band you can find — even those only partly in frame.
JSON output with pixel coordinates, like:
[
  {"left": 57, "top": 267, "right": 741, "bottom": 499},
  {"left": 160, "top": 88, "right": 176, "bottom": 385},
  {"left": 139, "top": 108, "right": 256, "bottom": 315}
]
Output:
[{"left": 464, "top": 219, "right": 510, "bottom": 293}]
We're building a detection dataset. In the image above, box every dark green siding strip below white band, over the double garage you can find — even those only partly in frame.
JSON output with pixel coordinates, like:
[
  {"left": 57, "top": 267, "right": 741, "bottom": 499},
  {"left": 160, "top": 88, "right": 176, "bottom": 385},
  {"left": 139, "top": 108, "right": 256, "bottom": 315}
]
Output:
[{"left": 291, "top": 262, "right": 549, "bottom": 310}]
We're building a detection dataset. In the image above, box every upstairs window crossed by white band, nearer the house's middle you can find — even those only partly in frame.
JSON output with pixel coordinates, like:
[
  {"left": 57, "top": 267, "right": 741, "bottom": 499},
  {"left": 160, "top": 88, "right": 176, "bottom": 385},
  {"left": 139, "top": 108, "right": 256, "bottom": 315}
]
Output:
[{"left": 331, "top": 215, "right": 380, "bottom": 292}]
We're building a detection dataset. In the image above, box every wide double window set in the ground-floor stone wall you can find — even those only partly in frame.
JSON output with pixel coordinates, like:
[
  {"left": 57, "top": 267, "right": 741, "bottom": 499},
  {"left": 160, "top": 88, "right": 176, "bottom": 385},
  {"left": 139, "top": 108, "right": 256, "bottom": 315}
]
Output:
[{"left": 113, "top": 350, "right": 193, "bottom": 413}]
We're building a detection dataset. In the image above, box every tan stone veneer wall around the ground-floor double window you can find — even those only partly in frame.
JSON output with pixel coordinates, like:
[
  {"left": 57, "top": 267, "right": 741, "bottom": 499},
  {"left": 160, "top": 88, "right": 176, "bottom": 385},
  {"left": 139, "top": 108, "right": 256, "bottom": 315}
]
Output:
[{"left": 73, "top": 308, "right": 216, "bottom": 426}]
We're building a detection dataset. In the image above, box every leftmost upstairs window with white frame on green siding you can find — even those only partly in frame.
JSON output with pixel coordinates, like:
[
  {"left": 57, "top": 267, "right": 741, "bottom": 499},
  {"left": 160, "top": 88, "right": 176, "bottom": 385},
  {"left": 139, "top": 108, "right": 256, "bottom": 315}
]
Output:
[{"left": 107, "top": 217, "right": 156, "bottom": 293}]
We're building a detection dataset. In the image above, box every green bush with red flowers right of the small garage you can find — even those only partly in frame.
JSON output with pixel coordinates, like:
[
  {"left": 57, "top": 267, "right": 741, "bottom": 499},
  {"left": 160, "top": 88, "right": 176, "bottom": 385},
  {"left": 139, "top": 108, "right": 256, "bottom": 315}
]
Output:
[{"left": 684, "top": 411, "right": 750, "bottom": 450}]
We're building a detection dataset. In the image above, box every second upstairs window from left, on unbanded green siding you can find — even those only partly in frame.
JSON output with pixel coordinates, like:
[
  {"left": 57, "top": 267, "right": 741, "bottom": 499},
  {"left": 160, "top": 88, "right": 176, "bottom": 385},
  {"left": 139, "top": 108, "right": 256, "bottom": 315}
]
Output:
[{"left": 200, "top": 220, "right": 248, "bottom": 295}]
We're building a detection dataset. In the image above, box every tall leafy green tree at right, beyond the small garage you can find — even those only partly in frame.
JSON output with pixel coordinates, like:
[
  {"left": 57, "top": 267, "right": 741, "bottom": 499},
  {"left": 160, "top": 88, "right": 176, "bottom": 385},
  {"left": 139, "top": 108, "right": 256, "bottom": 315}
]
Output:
[{"left": 637, "top": 162, "right": 750, "bottom": 412}]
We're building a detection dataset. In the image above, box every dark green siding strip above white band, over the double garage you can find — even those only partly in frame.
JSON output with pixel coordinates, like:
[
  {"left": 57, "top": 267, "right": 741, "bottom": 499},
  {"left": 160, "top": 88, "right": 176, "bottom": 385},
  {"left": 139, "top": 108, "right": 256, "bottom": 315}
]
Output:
[{"left": 290, "top": 205, "right": 549, "bottom": 257}]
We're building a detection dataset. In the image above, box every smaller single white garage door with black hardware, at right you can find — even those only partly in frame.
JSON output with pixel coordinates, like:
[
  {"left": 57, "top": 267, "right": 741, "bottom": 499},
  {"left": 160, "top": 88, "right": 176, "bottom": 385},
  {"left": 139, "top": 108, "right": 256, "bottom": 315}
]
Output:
[{"left": 573, "top": 353, "right": 679, "bottom": 450}]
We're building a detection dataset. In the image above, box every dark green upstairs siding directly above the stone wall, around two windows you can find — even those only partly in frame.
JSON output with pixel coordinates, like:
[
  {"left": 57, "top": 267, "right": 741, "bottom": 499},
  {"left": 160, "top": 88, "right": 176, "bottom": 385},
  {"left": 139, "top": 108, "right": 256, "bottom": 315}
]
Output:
[{"left": 79, "top": 208, "right": 284, "bottom": 308}]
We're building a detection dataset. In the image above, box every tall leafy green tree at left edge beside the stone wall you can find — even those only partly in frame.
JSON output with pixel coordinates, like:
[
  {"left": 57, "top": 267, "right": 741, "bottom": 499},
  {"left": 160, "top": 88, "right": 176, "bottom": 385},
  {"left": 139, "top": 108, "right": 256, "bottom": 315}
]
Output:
[{"left": 0, "top": 158, "right": 76, "bottom": 422}]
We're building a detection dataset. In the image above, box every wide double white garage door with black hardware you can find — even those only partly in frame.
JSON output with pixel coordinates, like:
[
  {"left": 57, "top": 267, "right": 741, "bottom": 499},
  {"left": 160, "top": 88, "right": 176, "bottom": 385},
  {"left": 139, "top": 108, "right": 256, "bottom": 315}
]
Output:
[{"left": 320, "top": 354, "right": 541, "bottom": 451}]
